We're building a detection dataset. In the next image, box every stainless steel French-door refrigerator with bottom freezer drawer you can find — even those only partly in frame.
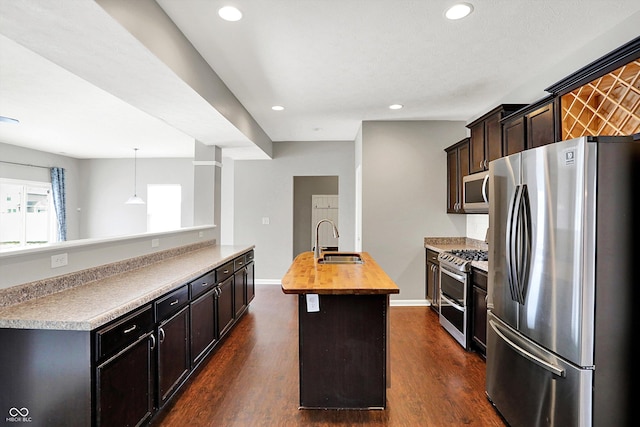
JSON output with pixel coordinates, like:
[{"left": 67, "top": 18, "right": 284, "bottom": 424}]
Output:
[{"left": 486, "top": 137, "right": 640, "bottom": 427}]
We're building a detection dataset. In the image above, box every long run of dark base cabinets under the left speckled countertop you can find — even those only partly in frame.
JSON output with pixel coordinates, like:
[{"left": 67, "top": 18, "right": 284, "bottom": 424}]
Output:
[{"left": 0, "top": 251, "right": 255, "bottom": 427}]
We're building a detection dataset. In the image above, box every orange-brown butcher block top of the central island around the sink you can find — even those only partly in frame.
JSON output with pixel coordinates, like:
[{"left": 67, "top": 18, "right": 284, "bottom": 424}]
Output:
[{"left": 282, "top": 252, "right": 400, "bottom": 295}]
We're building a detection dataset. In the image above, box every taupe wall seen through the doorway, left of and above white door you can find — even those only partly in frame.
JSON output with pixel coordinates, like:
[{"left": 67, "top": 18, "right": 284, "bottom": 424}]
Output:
[{"left": 293, "top": 176, "right": 339, "bottom": 258}]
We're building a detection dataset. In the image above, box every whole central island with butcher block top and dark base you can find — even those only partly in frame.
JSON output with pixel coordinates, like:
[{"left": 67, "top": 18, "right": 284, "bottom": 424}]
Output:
[{"left": 282, "top": 252, "right": 400, "bottom": 409}]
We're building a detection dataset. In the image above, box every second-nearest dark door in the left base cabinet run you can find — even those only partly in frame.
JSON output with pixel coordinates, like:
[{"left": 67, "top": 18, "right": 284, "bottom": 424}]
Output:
[{"left": 158, "top": 306, "right": 191, "bottom": 406}]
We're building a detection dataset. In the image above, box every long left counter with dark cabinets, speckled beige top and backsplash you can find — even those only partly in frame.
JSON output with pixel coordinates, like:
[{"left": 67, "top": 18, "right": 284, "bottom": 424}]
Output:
[{"left": 0, "top": 241, "right": 254, "bottom": 427}]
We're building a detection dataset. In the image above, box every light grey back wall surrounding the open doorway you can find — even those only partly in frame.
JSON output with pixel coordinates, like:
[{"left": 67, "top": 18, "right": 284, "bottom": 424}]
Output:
[{"left": 232, "top": 141, "right": 355, "bottom": 281}]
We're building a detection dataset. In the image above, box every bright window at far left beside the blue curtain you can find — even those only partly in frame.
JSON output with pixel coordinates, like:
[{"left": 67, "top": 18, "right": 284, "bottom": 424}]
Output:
[{"left": 0, "top": 179, "right": 56, "bottom": 249}]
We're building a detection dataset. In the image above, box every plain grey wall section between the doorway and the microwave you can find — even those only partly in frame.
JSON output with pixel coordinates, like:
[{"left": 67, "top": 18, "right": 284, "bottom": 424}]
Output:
[{"left": 362, "top": 121, "right": 467, "bottom": 300}]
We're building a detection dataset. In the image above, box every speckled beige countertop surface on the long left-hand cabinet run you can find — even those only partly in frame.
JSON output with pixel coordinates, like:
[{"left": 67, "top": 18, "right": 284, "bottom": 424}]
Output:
[{"left": 0, "top": 245, "right": 254, "bottom": 331}]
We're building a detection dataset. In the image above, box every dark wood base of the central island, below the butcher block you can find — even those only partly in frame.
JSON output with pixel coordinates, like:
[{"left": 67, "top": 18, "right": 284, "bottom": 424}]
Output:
[{"left": 298, "top": 295, "right": 388, "bottom": 409}]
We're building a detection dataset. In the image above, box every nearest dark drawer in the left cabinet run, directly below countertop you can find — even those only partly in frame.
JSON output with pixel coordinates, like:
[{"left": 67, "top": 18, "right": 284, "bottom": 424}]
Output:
[{"left": 96, "top": 305, "right": 154, "bottom": 360}]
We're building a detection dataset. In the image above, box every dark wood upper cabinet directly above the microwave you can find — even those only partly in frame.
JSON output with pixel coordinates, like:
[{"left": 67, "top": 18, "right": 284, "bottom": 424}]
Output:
[{"left": 467, "top": 104, "right": 525, "bottom": 173}]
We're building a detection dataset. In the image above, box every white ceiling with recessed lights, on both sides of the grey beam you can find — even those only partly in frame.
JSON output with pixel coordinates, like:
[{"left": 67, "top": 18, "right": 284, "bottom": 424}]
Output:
[{"left": 0, "top": 0, "right": 640, "bottom": 158}]
